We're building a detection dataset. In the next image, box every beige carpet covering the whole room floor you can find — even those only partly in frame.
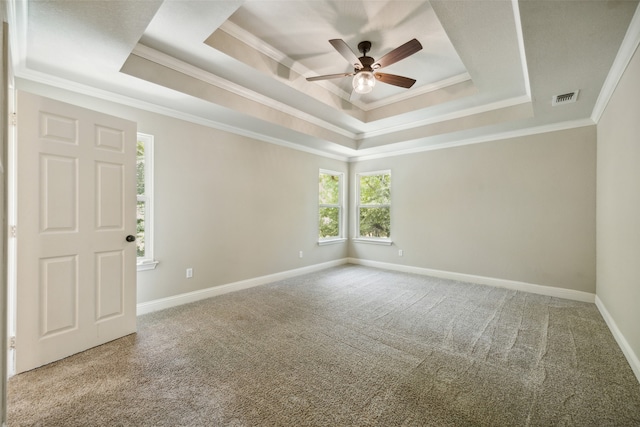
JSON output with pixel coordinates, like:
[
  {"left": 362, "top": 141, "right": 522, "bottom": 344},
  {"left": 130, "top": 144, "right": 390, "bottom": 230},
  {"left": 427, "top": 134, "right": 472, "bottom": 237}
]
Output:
[{"left": 8, "top": 265, "right": 640, "bottom": 427}]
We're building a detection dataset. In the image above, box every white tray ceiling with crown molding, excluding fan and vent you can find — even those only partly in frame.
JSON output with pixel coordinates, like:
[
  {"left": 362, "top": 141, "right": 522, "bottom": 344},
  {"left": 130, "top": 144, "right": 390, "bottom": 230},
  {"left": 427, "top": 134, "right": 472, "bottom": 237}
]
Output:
[{"left": 9, "top": 0, "right": 637, "bottom": 158}]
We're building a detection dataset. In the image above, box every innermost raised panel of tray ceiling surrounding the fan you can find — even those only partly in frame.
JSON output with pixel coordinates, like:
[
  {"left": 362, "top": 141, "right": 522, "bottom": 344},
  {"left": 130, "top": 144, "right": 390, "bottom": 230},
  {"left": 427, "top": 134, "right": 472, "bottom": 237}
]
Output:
[{"left": 229, "top": 0, "right": 466, "bottom": 105}]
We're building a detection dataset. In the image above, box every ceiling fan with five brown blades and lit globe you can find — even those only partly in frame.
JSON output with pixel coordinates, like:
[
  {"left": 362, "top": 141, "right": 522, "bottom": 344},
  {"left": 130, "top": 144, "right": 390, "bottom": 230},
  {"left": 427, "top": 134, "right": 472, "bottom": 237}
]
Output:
[{"left": 307, "top": 39, "right": 422, "bottom": 93}]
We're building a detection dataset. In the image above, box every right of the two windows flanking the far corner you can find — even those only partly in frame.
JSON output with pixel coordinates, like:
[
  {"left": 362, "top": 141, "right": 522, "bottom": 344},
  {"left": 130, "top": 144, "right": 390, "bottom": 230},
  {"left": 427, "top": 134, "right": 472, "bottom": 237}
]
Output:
[{"left": 356, "top": 171, "right": 391, "bottom": 244}]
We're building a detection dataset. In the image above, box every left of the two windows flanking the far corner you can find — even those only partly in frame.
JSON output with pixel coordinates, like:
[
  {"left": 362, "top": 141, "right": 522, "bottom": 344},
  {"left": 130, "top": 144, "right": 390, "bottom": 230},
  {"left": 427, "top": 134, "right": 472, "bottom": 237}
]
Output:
[{"left": 318, "top": 169, "right": 344, "bottom": 244}]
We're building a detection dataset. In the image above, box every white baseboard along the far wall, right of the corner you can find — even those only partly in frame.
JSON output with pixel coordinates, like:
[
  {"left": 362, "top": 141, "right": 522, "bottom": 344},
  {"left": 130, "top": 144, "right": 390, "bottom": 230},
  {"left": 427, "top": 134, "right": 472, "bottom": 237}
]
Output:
[{"left": 348, "top": 258, "right": 595, "bottom": 303}]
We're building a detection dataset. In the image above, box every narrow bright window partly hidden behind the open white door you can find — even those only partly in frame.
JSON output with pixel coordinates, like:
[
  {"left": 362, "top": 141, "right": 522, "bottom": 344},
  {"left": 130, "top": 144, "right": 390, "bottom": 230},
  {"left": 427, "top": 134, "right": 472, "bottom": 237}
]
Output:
[{"left": 136, "top": 133, "right": 158, "bottom": 271}]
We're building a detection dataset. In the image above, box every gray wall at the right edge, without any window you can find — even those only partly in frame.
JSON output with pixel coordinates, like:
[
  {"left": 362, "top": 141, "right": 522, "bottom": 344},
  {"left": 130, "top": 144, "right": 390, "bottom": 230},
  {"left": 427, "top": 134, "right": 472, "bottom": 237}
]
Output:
[{"left": 597, "top": 43, "right": 640, "bottom": 364}]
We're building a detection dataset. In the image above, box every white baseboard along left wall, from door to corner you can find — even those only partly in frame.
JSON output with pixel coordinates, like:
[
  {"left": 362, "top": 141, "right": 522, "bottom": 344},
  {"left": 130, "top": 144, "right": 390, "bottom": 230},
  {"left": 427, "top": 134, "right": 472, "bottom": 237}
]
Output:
[{"left": 136, "top": 258, "right": 347, "bottom": 316}]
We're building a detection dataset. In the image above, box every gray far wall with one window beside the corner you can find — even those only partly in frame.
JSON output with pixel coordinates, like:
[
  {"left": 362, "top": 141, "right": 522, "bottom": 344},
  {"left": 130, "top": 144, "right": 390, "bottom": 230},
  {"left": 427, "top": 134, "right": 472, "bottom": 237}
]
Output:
[{"left": 349, "top": 126, "right": 596, "bottom": 293}]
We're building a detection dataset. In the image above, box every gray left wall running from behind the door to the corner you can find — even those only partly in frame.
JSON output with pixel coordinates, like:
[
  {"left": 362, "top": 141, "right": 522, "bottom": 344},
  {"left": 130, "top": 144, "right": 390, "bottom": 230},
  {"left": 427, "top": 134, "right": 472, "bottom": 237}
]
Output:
[{"left": 17, "top": 80, "right": 348, "bottom": 303}]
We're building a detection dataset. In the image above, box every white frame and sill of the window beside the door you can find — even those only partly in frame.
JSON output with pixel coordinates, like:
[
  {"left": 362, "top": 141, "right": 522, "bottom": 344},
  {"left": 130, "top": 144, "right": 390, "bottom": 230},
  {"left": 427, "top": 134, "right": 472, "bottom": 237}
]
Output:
[{"left": 136, "top": 132, "right": 158, "bottom": 271}]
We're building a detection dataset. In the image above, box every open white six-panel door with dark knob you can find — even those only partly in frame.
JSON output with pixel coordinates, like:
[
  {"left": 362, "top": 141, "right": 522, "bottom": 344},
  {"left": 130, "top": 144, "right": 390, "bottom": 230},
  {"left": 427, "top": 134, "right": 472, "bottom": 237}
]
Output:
[{"left": 16, "top": 92, "right": 136, "bottom": 373}]
